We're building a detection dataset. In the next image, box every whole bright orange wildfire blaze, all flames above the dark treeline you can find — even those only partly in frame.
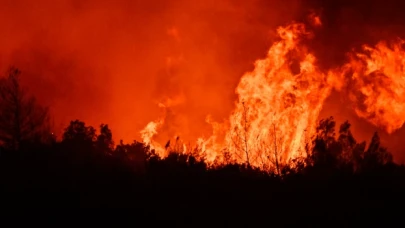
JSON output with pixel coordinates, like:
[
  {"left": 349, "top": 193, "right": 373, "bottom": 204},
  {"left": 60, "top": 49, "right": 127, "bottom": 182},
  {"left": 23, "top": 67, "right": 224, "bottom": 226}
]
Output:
[{"left": 141, "top": 15, "right": 405, "bottom": 168}]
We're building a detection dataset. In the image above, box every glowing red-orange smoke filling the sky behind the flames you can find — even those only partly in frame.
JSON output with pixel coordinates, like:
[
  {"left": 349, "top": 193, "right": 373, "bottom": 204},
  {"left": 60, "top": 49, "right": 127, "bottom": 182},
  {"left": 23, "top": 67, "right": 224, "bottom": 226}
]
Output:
[{"left": 0, "top": 0, "right": 405, "bottom": 160}]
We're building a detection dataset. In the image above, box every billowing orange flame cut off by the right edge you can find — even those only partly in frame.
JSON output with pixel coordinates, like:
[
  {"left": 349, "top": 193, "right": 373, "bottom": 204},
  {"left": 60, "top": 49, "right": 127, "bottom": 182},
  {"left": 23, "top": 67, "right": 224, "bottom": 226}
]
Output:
[{"left": 342, "top": 40, "right": 405, "bottom": 133}]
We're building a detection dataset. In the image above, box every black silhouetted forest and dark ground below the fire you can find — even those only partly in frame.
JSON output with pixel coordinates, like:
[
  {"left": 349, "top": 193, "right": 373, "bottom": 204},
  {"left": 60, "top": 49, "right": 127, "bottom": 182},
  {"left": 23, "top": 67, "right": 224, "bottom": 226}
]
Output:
[{"left": 0, "top": 68, "right": 405, "bottom": 227}]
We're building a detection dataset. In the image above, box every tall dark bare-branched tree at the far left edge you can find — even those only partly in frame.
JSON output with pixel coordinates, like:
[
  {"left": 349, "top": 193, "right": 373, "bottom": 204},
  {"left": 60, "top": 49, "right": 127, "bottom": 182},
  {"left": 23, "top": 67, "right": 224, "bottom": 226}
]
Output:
[{"left": 0, "top": 68, "right": 51, "bottom": 150}]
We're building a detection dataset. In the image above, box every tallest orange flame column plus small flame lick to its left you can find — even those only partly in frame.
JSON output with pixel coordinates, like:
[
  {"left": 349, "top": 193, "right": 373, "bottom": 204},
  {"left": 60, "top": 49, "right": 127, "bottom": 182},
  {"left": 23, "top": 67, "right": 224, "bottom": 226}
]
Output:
[{"left": 142, "top": 20, "right": 331, "bottom": 167}]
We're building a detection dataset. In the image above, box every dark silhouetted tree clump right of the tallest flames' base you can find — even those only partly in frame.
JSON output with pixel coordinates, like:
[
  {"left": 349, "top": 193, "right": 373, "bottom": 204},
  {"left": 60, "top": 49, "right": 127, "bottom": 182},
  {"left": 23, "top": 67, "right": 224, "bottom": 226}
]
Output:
[{"left": 309, "top": 117, "right": 393, "bottom": 175}]
